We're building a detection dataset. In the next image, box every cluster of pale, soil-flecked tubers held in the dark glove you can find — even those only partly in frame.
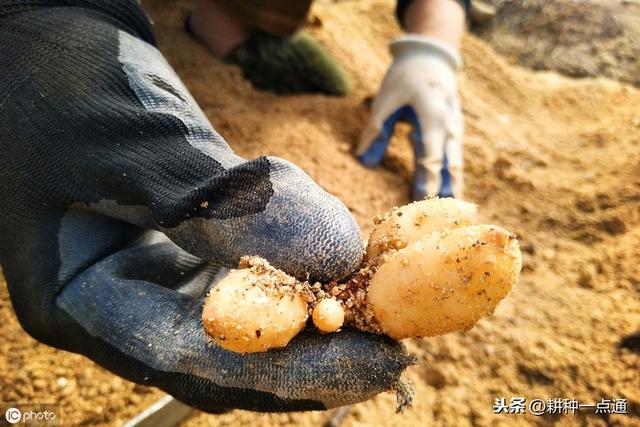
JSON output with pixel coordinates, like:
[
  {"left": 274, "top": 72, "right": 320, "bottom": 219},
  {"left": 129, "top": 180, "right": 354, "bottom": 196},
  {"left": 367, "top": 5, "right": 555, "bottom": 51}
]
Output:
[{"left": 202, "top": 198, "right": 522, "bottom": 353}]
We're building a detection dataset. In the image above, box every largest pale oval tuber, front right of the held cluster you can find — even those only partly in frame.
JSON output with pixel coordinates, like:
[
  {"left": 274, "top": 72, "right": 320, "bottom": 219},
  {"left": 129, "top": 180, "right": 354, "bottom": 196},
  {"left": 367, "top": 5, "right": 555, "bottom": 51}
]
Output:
[{"left": 367, "top": 225, "right": 520, "bottom": 339}]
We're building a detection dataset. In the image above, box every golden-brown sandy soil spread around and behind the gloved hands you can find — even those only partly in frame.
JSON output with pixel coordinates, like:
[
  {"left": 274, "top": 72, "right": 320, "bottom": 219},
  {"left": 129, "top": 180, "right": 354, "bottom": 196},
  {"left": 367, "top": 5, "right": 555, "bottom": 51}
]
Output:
[{"left": 0, "top": 0, "right": 640, "bottom": 426}]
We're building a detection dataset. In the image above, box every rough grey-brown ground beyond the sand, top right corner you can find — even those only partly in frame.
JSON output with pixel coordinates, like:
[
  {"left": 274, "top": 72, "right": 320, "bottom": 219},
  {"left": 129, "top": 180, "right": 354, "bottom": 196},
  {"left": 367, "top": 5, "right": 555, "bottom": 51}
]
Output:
[{"left": 481, "top": 0, "right": 640, "bottom": 86}]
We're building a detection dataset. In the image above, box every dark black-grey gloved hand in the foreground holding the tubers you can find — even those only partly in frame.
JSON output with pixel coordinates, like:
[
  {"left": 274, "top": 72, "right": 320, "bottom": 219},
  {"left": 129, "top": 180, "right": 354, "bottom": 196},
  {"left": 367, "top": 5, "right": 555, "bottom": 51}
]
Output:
[{"left": 0, "top": 0, "right": 411, "bottom": 412}]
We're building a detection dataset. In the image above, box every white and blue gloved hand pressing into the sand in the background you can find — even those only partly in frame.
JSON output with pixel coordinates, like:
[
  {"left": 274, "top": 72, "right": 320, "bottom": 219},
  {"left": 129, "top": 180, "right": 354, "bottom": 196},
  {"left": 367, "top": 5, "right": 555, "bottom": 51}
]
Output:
[{"left": 357, "top": 34, "right": 463, "bottom": 200}]
